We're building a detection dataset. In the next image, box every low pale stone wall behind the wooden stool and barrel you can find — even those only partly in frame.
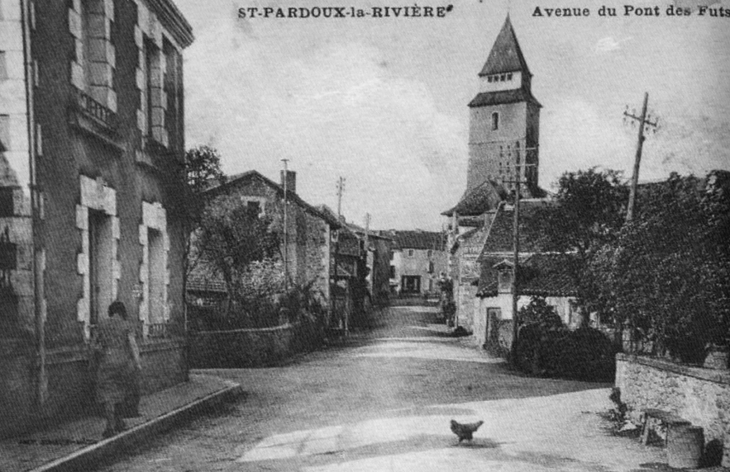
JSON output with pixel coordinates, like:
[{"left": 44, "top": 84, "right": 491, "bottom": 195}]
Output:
[{"left": 616, "top": 354, "right": 730, "bottom": 441}]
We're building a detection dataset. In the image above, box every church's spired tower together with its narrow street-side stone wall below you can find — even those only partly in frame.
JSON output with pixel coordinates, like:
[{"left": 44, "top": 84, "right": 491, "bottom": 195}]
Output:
[{"left": 442, "top": 16, "right": 545, "bottom": 332}]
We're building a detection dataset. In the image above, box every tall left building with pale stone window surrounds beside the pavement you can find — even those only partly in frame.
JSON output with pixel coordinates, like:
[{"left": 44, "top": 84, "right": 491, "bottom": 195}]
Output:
[{"left": 0, "top": 0, "right": 193, "bottom": 434}]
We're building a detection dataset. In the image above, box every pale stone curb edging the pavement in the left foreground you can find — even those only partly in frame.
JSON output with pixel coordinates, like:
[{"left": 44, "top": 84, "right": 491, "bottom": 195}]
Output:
[{"left": 29, "top": 379, "right": 243, "bottom": 472}]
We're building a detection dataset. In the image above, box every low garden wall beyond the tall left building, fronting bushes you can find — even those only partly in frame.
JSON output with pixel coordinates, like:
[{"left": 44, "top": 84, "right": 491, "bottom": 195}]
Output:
[{"left": 190, "top": 322, "right": 323, "bottom": 368}]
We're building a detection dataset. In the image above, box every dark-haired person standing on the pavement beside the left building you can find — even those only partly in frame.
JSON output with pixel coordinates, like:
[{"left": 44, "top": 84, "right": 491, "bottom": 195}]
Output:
[{"left": 95, "top": 301, "right": 142, "bottom": 438}]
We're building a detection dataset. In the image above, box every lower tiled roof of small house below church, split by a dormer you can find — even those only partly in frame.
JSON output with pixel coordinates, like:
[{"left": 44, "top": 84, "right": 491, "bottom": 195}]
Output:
[{"left": 477, "top": 254, "right": 577, "bottom": 297}]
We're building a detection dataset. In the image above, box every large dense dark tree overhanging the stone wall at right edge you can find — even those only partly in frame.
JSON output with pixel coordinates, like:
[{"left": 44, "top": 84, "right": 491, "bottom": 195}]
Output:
[{"left": 593, "top": 173, "right": 730, "bottom": 363}]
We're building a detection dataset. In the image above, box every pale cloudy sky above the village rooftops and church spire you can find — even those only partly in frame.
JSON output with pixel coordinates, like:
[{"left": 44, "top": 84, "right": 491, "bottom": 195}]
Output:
[{"left": 175, "top": 0, "right": 730, "bottom": 230}]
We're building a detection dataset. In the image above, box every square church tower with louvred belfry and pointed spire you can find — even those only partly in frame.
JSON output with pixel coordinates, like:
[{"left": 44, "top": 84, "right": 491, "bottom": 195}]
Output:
[{"left": 466, "top": 16, "right": 541, "bottom": 196}]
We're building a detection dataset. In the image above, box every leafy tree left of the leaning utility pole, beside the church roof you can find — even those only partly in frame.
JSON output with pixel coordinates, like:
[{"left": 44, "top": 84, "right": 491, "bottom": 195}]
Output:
[{"left": 530, "top": 168, "right": 628, "bottom": 317}]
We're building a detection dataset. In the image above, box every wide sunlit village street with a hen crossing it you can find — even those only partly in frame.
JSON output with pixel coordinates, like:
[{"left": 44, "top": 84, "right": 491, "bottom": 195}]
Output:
[{"left": 95, "top": 307, "right": 665, "bottom": 472}]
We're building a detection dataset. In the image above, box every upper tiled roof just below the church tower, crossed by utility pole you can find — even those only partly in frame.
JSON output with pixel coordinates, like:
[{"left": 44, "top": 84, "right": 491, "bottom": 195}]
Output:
[{"left": 480, "top": 200, "right": 548, "bottom": 259}]
